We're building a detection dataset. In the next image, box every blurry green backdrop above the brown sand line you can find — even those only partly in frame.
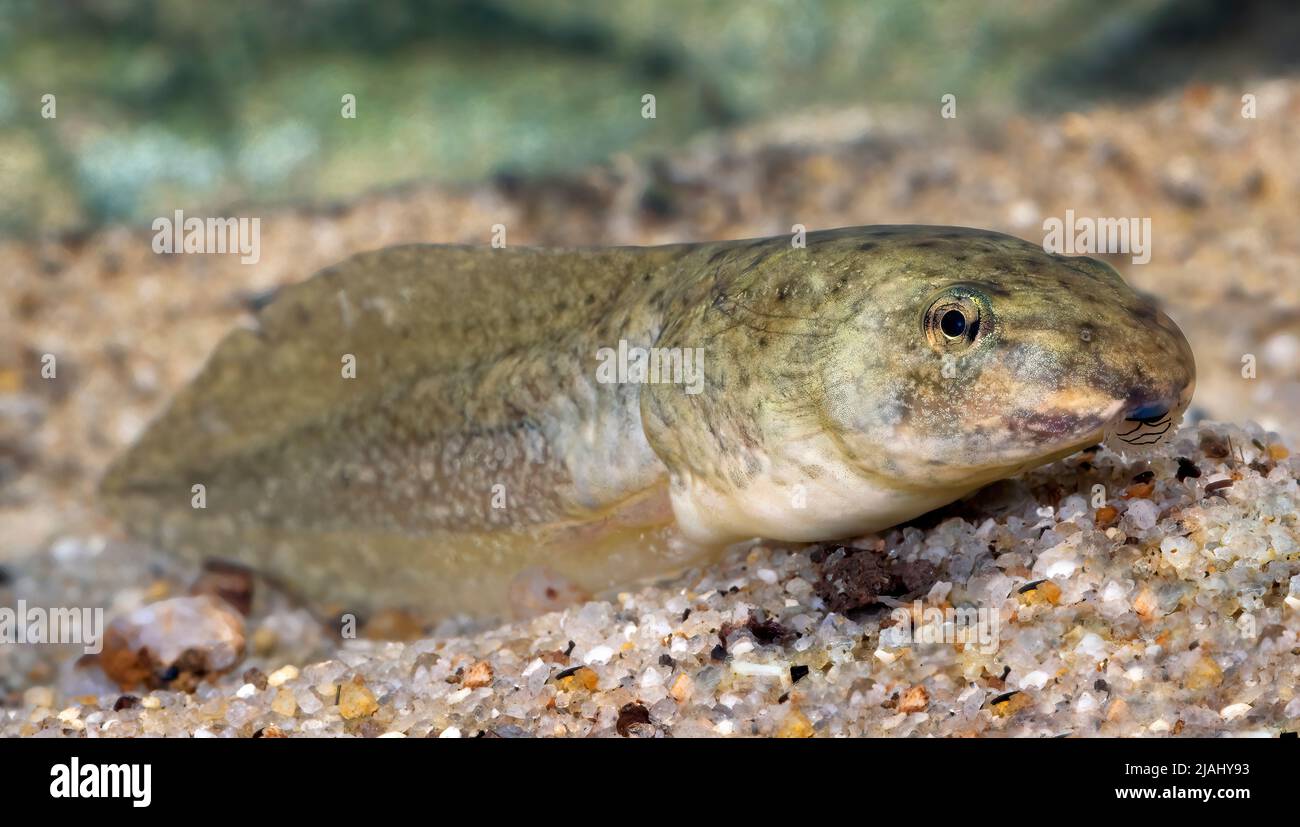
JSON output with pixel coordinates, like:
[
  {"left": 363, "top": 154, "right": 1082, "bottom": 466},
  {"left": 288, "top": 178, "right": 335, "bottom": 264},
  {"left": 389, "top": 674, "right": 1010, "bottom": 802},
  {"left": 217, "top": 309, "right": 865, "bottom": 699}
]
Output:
[{"left": 0, "top": 0, "right": 1300, "bottom": 233}]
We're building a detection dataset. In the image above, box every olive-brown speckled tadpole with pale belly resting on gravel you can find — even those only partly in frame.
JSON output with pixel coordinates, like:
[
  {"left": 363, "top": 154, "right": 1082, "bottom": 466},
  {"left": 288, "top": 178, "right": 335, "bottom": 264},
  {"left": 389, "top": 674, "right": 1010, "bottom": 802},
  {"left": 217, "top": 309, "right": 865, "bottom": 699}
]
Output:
[{"left": 104, "top": 226, "right": 1195, "bottom": 615}]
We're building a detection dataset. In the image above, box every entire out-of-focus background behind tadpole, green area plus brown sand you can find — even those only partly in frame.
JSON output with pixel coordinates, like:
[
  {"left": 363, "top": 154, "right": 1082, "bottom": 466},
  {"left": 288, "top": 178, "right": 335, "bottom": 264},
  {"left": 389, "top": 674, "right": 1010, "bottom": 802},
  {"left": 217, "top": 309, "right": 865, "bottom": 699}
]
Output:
[{"left": 0, "top": 0, "right": 1300, "bottom": 551}]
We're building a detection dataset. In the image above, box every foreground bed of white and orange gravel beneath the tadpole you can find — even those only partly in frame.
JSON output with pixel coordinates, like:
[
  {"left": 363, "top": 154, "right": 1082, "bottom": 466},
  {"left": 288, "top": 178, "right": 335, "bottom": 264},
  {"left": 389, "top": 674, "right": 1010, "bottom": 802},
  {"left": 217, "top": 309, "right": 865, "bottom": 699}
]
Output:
[{"left": 0, "top": 423, "right": 1300, "bottom": 737}]
